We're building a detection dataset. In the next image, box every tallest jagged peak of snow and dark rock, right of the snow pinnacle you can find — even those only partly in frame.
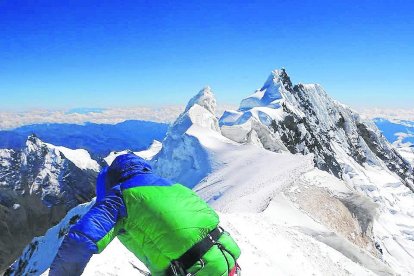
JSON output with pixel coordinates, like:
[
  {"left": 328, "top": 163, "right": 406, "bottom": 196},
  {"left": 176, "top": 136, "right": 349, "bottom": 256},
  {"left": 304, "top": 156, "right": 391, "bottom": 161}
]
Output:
[{"left": 220, "top": 69, "right": 414, "bottom": 189}]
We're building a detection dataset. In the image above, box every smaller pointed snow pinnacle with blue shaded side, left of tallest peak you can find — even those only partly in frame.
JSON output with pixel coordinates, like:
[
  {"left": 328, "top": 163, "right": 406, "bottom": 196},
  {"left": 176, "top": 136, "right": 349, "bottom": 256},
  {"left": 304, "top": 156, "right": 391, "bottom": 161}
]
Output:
[{"left": 154, "top": 87, "right": 220, "bottom": 187}]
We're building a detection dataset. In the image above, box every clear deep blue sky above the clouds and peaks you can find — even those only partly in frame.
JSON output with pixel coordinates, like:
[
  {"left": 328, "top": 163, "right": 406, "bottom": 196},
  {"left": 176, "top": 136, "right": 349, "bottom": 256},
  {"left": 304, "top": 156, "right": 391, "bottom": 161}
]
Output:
[{"left": 0, "top": 0, "right": 414, "bottom": 110}]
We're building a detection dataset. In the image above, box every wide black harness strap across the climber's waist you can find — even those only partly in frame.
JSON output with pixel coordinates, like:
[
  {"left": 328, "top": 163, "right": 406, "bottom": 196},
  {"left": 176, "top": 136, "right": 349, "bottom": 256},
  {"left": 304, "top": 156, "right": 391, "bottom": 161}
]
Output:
[{"left": 167, "top": 227, "right": 223, "bottom": 275}]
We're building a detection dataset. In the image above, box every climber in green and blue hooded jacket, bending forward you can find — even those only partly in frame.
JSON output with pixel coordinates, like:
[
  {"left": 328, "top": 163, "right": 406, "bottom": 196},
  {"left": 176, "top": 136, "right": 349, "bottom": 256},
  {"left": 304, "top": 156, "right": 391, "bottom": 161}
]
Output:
[{"left": 49, "top": 153, "right": 240, "bottom": 276}]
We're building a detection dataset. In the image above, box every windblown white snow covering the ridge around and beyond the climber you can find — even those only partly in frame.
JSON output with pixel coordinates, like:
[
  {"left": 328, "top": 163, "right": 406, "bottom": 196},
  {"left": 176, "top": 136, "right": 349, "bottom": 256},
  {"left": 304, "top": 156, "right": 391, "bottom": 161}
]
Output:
[{"left": 11, "top": 74, "right": 414, "bottom": 275}]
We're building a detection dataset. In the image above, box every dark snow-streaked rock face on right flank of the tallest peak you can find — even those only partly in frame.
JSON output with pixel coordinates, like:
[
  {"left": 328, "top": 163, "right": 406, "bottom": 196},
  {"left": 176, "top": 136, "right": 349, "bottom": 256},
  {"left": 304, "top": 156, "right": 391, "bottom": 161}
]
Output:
[{"left": 272, "top": 74, "right": 414, "bottom": 191}]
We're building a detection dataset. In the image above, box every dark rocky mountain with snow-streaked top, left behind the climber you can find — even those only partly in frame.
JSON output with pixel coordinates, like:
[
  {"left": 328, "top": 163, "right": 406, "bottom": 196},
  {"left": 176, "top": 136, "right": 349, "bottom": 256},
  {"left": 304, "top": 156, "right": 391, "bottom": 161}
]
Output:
[{"left": 0, "top": 136, "right": 97, "bottom": 271}]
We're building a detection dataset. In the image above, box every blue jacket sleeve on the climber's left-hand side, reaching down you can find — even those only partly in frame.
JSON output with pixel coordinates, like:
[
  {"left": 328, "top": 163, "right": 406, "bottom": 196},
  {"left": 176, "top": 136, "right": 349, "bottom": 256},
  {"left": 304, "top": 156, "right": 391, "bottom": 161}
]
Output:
[{"left": 49, "top": 187, "right": 126, "bottom": 276}]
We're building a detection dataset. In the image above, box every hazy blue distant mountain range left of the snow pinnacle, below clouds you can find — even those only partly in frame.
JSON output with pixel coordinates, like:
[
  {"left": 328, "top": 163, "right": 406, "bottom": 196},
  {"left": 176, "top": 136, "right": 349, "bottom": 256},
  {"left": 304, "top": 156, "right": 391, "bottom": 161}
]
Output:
[{"left": 0, "top": 120, "right": 168, "bottom": 157}]
